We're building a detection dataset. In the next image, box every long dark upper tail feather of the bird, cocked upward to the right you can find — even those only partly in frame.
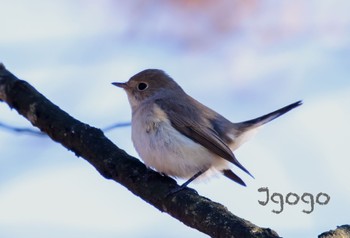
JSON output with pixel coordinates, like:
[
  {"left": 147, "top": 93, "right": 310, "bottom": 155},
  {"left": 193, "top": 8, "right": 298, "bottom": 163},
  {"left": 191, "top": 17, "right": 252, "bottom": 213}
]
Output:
[{"left": 237, "top": 101, "right": 303, "bottom": 129}]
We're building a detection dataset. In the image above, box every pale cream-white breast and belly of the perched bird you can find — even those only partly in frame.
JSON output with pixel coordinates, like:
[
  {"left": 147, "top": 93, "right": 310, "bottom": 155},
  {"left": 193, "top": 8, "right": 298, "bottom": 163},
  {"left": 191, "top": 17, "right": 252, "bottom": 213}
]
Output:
[{"left": 132, "top": 117, "right": 228, "bottom": 178}]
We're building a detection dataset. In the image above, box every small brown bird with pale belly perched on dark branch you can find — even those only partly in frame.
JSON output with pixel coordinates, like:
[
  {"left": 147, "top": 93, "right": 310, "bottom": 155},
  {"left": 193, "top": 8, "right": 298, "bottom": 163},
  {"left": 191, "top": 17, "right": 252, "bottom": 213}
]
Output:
[{"left": 112, "top": 69, "right": 302, "bottom": 192}]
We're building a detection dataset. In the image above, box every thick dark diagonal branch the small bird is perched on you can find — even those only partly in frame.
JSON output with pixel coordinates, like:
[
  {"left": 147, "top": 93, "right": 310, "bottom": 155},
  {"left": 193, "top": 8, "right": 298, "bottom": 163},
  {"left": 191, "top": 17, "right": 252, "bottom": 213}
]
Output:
[{"left": 0, "top": 63, "right": 279, "bottom": 238}]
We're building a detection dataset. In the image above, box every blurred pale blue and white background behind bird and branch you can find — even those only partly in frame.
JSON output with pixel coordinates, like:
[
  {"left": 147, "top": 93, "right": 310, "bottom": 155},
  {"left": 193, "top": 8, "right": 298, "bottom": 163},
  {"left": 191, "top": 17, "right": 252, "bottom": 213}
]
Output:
[{"left": 0, "top": 0, "right": 350, "bottom": 238}]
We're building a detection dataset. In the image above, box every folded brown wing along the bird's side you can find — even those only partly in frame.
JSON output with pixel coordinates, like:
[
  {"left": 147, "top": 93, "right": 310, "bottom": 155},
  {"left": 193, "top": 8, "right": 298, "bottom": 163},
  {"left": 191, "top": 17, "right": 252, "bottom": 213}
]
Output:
[{"left": 156, "top": 99, "right": 253, "bottom": 177}]
